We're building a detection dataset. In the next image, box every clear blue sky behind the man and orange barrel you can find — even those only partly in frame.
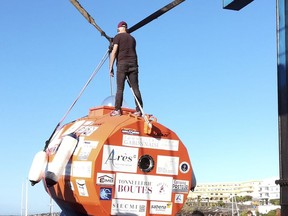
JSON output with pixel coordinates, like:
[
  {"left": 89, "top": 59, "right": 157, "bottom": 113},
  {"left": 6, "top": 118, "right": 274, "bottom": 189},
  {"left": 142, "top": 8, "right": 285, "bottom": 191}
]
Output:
[{"left": 0, "top": 0, "right": 279, "bottom": 215}]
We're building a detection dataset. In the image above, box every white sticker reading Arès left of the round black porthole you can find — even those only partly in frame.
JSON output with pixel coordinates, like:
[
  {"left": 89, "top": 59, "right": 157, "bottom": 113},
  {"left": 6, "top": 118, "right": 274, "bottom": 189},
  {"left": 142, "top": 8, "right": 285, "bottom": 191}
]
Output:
[{"left": 102, "top": 145, "right": 138, "bottom": 173}]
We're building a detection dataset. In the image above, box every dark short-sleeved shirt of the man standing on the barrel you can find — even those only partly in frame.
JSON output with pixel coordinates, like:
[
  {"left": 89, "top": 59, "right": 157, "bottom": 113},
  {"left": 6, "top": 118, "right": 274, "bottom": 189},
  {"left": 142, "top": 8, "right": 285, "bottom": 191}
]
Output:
[{"left": 113, "top": 33, "right": 137, "bottom": 63}]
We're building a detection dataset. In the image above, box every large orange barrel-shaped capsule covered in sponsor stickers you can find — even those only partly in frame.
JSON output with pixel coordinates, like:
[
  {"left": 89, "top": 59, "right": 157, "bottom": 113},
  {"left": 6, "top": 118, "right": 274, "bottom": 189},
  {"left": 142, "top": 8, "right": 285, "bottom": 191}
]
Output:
[{"left": 44, "top": 106, "right": 196, "bottom": 216}]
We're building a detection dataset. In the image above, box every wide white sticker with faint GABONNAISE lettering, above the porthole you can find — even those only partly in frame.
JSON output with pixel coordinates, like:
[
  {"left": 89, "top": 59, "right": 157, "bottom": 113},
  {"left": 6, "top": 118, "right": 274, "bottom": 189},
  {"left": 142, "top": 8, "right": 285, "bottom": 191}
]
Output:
[{"left": 122, "top": 134, "right": 179, "bottom": 151}]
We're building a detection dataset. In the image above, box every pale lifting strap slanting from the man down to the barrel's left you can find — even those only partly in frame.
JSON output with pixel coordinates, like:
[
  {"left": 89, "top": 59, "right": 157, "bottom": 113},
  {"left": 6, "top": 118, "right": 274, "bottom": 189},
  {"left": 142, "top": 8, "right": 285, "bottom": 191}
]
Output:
[{"left": 44, "top": 49, "right": 109, "bottom": 151}]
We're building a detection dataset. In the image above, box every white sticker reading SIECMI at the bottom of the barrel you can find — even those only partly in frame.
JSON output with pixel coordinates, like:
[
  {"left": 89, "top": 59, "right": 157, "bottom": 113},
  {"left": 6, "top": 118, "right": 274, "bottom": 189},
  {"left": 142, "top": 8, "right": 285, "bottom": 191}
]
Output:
[{"left": 111, "top": 199, "right": 147, "bottom": 216}]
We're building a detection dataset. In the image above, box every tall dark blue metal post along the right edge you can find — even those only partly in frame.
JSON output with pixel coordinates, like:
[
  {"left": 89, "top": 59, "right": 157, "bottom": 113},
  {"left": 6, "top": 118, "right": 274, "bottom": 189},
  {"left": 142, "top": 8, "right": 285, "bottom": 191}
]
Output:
[{"left": 276, "top": 0, "right": 288, "bottom": 216}]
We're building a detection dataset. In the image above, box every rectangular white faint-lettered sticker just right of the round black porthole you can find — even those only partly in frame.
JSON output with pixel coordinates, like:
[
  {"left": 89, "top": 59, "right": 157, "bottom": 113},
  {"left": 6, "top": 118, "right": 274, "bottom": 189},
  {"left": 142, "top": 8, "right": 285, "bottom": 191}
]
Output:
[{"left": 156, "top": 155, "right": 179, "bottom": 175}]
